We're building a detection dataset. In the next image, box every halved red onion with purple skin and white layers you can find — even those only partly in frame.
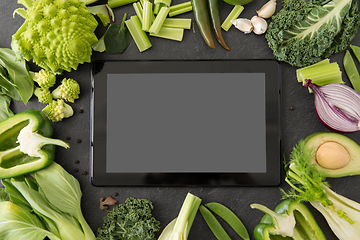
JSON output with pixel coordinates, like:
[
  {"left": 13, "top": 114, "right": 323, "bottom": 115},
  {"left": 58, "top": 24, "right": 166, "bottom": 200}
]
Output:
[{"left": 304, "top": 79, "right": 360, "bottom": 132}]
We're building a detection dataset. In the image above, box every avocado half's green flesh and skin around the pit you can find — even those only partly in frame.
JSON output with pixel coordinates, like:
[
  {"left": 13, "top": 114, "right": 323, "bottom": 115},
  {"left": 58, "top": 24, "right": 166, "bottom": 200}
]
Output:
[{"left": 305, "top": 132, "right": 360, "bottom": 178}]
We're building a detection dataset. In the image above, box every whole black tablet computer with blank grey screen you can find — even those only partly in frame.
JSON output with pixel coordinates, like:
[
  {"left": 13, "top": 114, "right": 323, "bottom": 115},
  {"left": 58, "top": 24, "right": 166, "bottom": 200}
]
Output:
[{"left": 91, "top": 60, "right": 281, "bottom": 186}]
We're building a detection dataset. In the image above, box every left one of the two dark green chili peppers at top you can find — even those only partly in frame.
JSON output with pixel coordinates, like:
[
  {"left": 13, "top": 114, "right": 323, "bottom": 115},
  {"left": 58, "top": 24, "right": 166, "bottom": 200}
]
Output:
[{"left": 191, "top": 0, "right": 216, "bottom": 49}]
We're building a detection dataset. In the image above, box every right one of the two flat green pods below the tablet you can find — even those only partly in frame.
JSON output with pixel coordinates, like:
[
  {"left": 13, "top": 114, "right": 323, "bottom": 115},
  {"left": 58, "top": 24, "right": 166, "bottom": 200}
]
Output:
[{"left": 205, "top": 202, "right": 250, "bottom": 240}]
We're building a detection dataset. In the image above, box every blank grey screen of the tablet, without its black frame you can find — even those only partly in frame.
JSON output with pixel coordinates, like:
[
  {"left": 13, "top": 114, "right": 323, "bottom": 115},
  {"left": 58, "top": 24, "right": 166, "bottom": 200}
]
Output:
[{"left": 106, "top": 73, "right": 266, "bottom": 173}]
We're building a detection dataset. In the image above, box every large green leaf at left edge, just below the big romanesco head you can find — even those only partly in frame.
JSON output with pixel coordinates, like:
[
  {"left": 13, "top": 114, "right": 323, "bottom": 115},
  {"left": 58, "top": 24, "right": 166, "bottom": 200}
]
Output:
[{"left": 0, "top": 48, "right": 34, "bottom": 105}]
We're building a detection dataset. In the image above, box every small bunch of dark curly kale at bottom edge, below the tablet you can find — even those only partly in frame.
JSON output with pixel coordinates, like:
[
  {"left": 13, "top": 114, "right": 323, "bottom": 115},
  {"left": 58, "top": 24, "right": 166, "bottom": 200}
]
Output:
[{"left": 97, "top": 198, "right": 160, "bottom": 240}]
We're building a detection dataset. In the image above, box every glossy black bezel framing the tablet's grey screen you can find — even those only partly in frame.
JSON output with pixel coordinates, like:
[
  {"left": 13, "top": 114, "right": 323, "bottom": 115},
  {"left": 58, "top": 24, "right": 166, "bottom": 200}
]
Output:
[{"left": 90, "top": 60, "right": 282, "bottom": 186}]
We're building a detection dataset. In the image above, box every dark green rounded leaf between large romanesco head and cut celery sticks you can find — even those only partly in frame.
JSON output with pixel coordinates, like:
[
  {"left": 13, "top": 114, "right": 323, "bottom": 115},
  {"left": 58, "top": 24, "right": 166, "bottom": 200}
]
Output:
[{"left": 104, "top": 13, "right": 131, "bottom": 54}]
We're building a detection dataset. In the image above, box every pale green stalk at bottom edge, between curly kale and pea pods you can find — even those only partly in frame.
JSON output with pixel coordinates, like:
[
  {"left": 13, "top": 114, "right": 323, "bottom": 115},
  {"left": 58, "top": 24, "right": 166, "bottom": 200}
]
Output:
[{"left": 158, "top": 193, "right": 201, "bottom": 240}]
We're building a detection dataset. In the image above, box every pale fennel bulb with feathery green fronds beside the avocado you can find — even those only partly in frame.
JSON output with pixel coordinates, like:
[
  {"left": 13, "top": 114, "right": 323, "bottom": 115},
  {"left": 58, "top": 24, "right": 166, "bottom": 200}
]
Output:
[{"left": 284, "top": 140, "right": 360, "bottom": 240}]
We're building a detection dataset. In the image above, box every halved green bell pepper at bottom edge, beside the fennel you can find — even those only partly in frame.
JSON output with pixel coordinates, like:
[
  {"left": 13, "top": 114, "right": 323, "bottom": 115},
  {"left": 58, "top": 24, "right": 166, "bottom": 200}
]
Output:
[{"left": 250, "top": 199, "right": 326, "bottom": 240}]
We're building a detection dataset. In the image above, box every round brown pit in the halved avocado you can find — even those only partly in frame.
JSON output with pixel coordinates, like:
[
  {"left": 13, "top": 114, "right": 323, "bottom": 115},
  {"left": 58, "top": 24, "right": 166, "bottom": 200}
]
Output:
[{"left": 315, "top": 141, "right": 350, "bottom": 169}]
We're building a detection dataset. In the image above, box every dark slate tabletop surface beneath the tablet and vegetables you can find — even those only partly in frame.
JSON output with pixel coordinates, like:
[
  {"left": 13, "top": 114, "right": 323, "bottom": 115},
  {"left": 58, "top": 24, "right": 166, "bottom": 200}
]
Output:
[{"left": 0, "top": 0, "right": 360, "bottom": 240}]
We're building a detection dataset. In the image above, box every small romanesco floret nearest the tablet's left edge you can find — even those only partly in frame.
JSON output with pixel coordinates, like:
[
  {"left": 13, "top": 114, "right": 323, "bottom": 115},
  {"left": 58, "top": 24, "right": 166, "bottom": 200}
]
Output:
[{"left": 52, "top": 78, "right": 80, "bottom": 103}]
